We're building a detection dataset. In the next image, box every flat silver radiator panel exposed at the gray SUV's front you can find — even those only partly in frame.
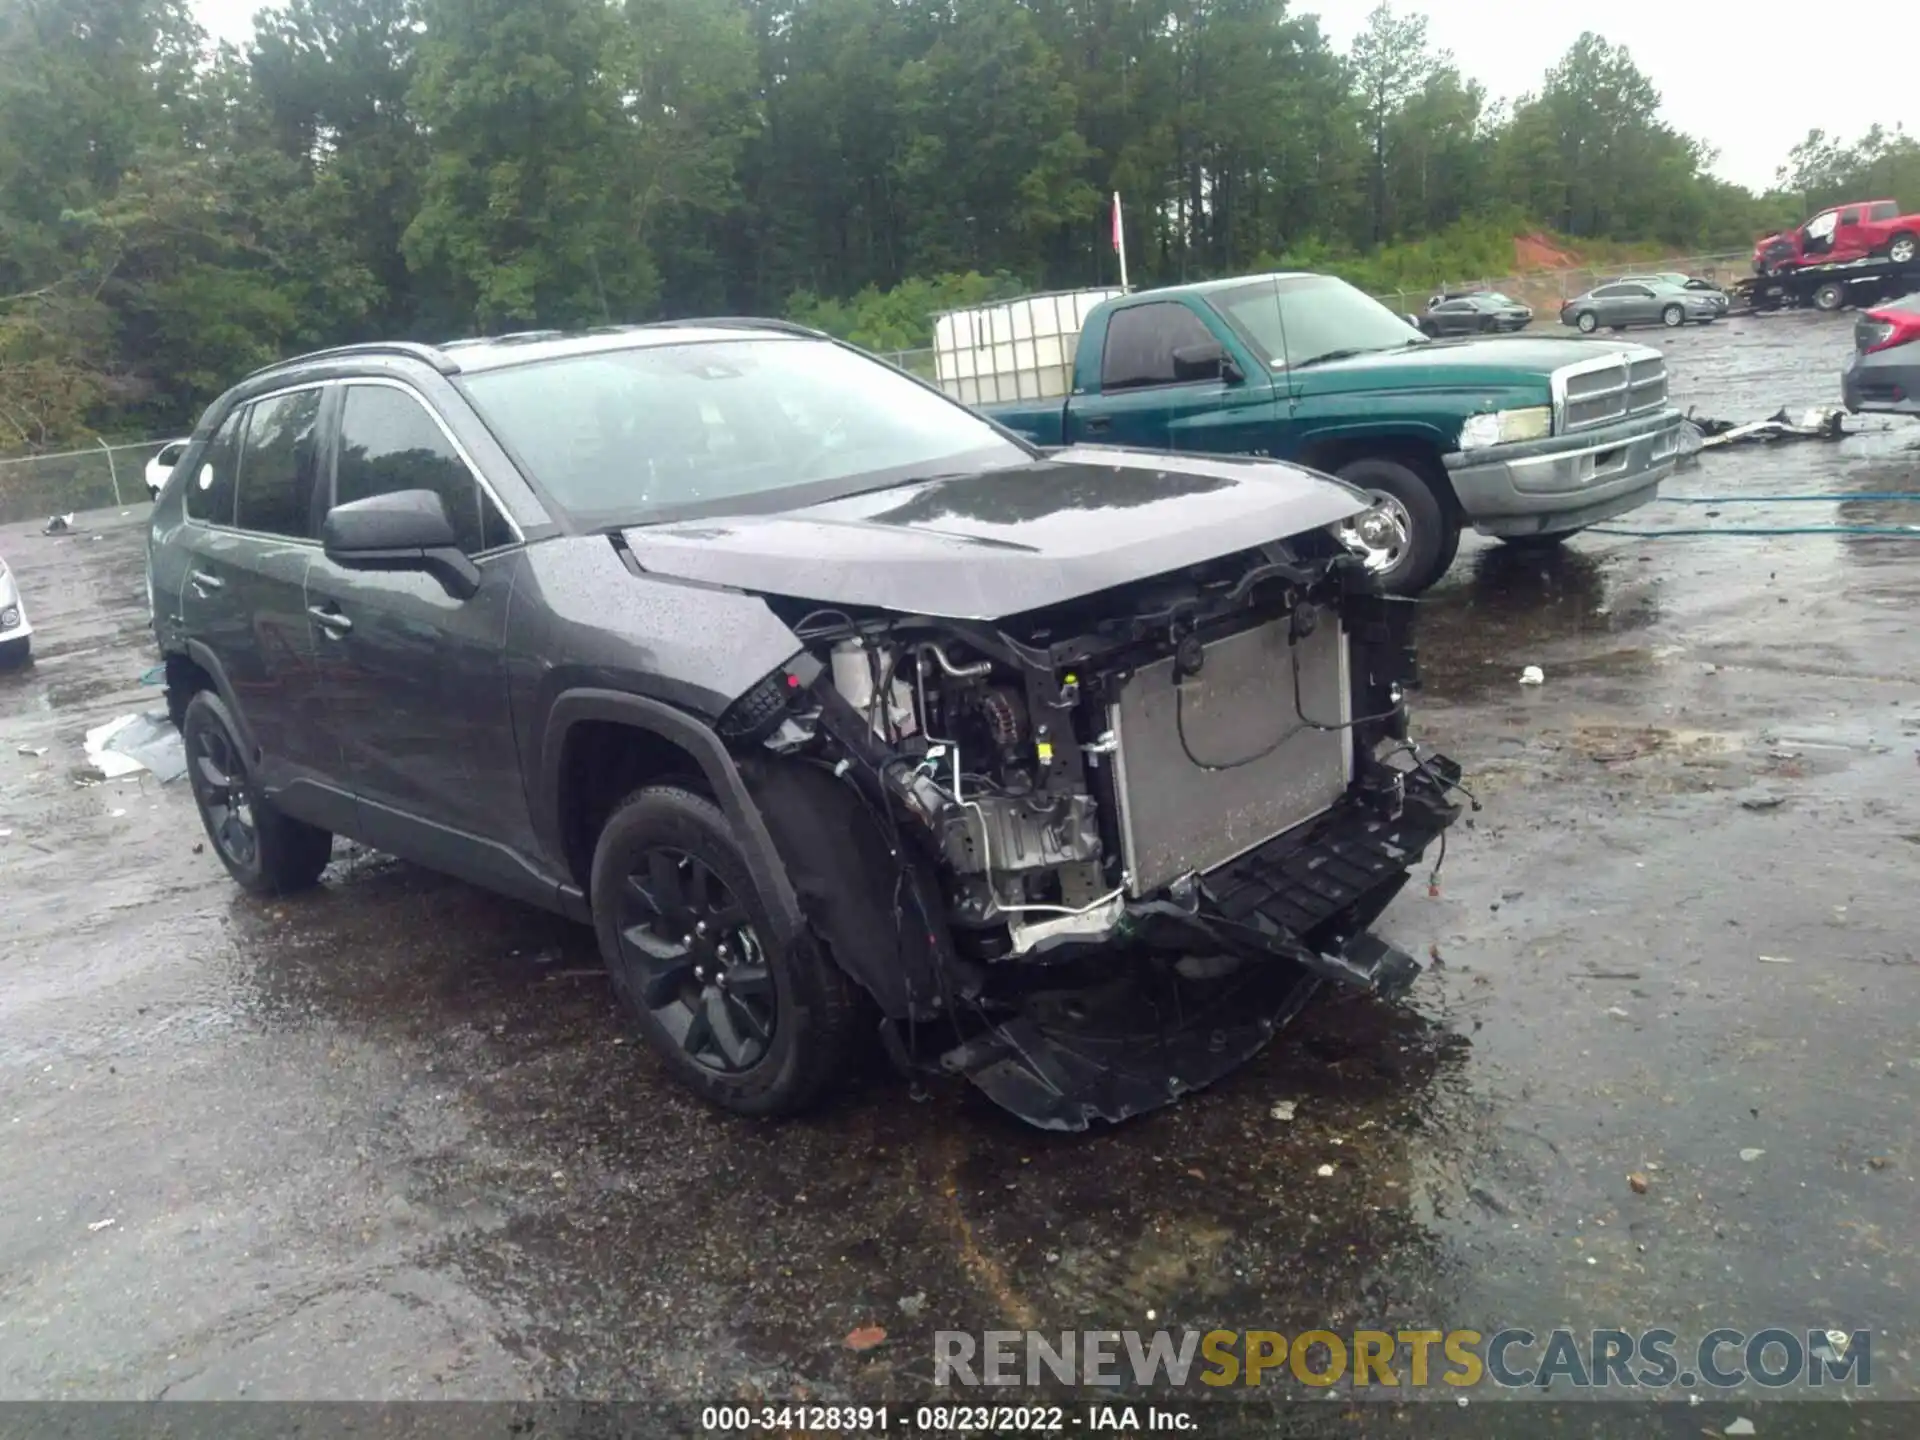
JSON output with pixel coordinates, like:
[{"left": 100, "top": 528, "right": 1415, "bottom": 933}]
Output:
[{"left": 1108, "top": 616, "right": 1354, "bottom": 895}]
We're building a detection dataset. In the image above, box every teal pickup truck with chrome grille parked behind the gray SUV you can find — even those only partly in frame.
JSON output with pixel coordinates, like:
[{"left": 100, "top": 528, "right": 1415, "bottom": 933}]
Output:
[{"left": 977, "top": 275, "right": 1682, "bottom": 595}]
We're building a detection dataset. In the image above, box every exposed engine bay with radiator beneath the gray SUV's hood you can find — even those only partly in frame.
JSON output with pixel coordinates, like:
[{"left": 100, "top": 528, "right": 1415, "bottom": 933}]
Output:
[{"left": 722, "top": 536, "right": 1443, "bottom": 964}]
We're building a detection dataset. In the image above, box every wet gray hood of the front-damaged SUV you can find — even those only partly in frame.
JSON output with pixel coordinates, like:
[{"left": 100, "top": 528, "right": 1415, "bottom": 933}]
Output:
[{"left": 622, "top": 445, "right": 1367, "bottom": 620}]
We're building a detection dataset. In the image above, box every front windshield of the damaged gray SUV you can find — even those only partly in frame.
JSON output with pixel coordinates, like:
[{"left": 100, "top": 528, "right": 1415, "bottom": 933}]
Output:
[{"left": 467, "top": 338, "right": 1029, "bottom": 528}]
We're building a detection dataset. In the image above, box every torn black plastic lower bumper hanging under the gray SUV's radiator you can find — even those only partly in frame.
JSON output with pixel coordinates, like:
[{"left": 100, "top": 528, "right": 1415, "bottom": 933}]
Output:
[{"left": 941, "top": 756, "right": 1459, "bottom": 1131}]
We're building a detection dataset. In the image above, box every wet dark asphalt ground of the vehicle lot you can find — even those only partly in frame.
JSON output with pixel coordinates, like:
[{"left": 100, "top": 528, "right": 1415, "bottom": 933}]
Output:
[{"left": 0, "top": 315, "right": 1920, "bottom": 1434}]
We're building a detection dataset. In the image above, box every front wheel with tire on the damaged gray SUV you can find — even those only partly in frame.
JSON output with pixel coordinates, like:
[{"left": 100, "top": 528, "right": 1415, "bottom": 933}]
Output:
[{"left": 591, "top": 785, "right": 858, "bottom": 1116}]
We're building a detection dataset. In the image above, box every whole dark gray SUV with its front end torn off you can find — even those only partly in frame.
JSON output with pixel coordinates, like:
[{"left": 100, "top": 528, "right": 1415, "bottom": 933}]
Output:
[{"left": 150, "top": 321, "right": 1459, "bottom": 1129}]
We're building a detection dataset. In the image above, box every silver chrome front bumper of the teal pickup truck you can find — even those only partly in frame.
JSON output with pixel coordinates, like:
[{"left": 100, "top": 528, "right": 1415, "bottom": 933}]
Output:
[{"left": 1446, "top": 409, "right": 1684, "bottom": 536}]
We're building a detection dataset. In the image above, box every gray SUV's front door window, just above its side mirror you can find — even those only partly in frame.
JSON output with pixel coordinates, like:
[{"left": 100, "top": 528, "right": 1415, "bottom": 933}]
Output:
[{"left": 334, "top": 386, "right": 513, "bottom": 555}]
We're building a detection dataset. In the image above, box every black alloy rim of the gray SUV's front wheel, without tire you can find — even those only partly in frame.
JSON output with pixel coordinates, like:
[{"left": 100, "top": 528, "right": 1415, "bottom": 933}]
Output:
[{"left": 618, "top": 845, "right": 780, "bottom": 1075}]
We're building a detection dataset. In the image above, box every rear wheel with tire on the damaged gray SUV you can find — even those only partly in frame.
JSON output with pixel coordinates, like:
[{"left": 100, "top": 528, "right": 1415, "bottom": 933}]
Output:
[{"left": 180, "top": 689, "right": 334, "bottom": 895}]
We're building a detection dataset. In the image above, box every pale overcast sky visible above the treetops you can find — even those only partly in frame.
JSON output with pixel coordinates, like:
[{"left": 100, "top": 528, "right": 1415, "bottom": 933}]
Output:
[{"left": 196, "top": 0, "right": 1920, "bottom": 194}]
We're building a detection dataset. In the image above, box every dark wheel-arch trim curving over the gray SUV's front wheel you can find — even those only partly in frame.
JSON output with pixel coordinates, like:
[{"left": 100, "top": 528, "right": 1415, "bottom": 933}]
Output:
[{"left": 532, "top": 689, "right": 804, "bottom": 945}]
